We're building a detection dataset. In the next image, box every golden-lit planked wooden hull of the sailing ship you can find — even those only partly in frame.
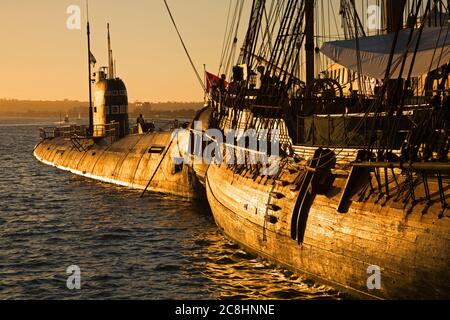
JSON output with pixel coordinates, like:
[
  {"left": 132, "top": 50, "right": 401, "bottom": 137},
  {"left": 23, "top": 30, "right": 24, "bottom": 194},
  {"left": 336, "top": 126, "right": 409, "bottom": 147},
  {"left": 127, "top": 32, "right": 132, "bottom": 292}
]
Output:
[{"left": 206, "top": 149, "right": 450, "bottom": 299}]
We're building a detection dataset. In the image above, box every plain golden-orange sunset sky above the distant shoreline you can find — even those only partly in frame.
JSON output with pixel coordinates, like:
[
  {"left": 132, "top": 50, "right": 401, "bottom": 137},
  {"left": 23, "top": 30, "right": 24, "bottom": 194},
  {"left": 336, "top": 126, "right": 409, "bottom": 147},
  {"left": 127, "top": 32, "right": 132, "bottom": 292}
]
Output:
[{"left": 0, "top": 0, "right": 251, "bottom": 102}]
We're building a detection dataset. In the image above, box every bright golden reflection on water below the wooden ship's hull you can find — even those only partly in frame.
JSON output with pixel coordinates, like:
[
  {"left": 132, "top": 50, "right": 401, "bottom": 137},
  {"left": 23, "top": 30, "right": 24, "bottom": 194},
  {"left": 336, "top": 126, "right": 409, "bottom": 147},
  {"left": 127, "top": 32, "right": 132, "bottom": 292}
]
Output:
[{"left": 190, "top": 230, "right": 340, "bottom": 299}]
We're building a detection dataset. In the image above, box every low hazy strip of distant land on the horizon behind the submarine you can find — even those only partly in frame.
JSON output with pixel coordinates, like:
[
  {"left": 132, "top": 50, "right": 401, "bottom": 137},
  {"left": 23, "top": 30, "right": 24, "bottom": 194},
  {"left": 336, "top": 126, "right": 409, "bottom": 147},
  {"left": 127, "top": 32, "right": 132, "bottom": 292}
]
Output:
[{"left": 0, "top": 99, "right": 203, "bottom": 117}]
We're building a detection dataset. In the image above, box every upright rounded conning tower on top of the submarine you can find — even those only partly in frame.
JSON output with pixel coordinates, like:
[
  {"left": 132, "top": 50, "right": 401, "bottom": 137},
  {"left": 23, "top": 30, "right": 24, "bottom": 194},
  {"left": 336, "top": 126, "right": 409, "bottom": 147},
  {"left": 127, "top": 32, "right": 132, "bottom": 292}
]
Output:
[{"left": 93, "top": 67, "right": 130, "bottom": 138}]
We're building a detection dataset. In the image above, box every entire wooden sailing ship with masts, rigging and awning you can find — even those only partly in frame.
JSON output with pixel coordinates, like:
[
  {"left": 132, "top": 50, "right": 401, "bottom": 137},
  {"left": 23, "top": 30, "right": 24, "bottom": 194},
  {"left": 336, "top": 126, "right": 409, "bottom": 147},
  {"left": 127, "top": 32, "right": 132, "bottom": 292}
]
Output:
[{"left": 192, "top": 0, "right": 450, "bottom": 299}]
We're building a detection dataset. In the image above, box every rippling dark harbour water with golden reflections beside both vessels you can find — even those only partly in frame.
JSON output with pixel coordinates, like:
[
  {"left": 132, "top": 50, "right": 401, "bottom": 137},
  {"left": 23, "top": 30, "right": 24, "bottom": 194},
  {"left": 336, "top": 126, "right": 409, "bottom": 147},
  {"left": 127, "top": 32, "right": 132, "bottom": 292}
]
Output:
[{"left": 0, "top": 119, "right": 342, "bottom": 299}]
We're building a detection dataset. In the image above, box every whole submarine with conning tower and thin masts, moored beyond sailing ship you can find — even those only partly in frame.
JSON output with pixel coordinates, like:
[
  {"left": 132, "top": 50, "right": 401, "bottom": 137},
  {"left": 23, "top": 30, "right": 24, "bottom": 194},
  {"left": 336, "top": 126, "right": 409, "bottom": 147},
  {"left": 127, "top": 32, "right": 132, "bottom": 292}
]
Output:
[{"left": 34, "top": 21, "right": 202, "bottom": 200}]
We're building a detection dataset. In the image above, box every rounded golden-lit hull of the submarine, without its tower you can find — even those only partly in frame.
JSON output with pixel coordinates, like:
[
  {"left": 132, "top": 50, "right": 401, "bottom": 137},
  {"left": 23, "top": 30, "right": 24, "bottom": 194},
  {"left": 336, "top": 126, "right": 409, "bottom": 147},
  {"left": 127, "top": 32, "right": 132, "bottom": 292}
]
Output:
[{"left": 34, "top": 132, "right": 201, "bottom": 199}]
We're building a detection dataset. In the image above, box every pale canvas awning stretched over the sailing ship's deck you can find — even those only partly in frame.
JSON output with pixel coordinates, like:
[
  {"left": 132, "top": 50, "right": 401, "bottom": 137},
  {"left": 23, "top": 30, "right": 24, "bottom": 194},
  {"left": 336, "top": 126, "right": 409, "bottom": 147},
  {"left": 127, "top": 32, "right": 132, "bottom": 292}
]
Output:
[{"left": 321, "top": 26, "right": 450, "bottom": 79}]
